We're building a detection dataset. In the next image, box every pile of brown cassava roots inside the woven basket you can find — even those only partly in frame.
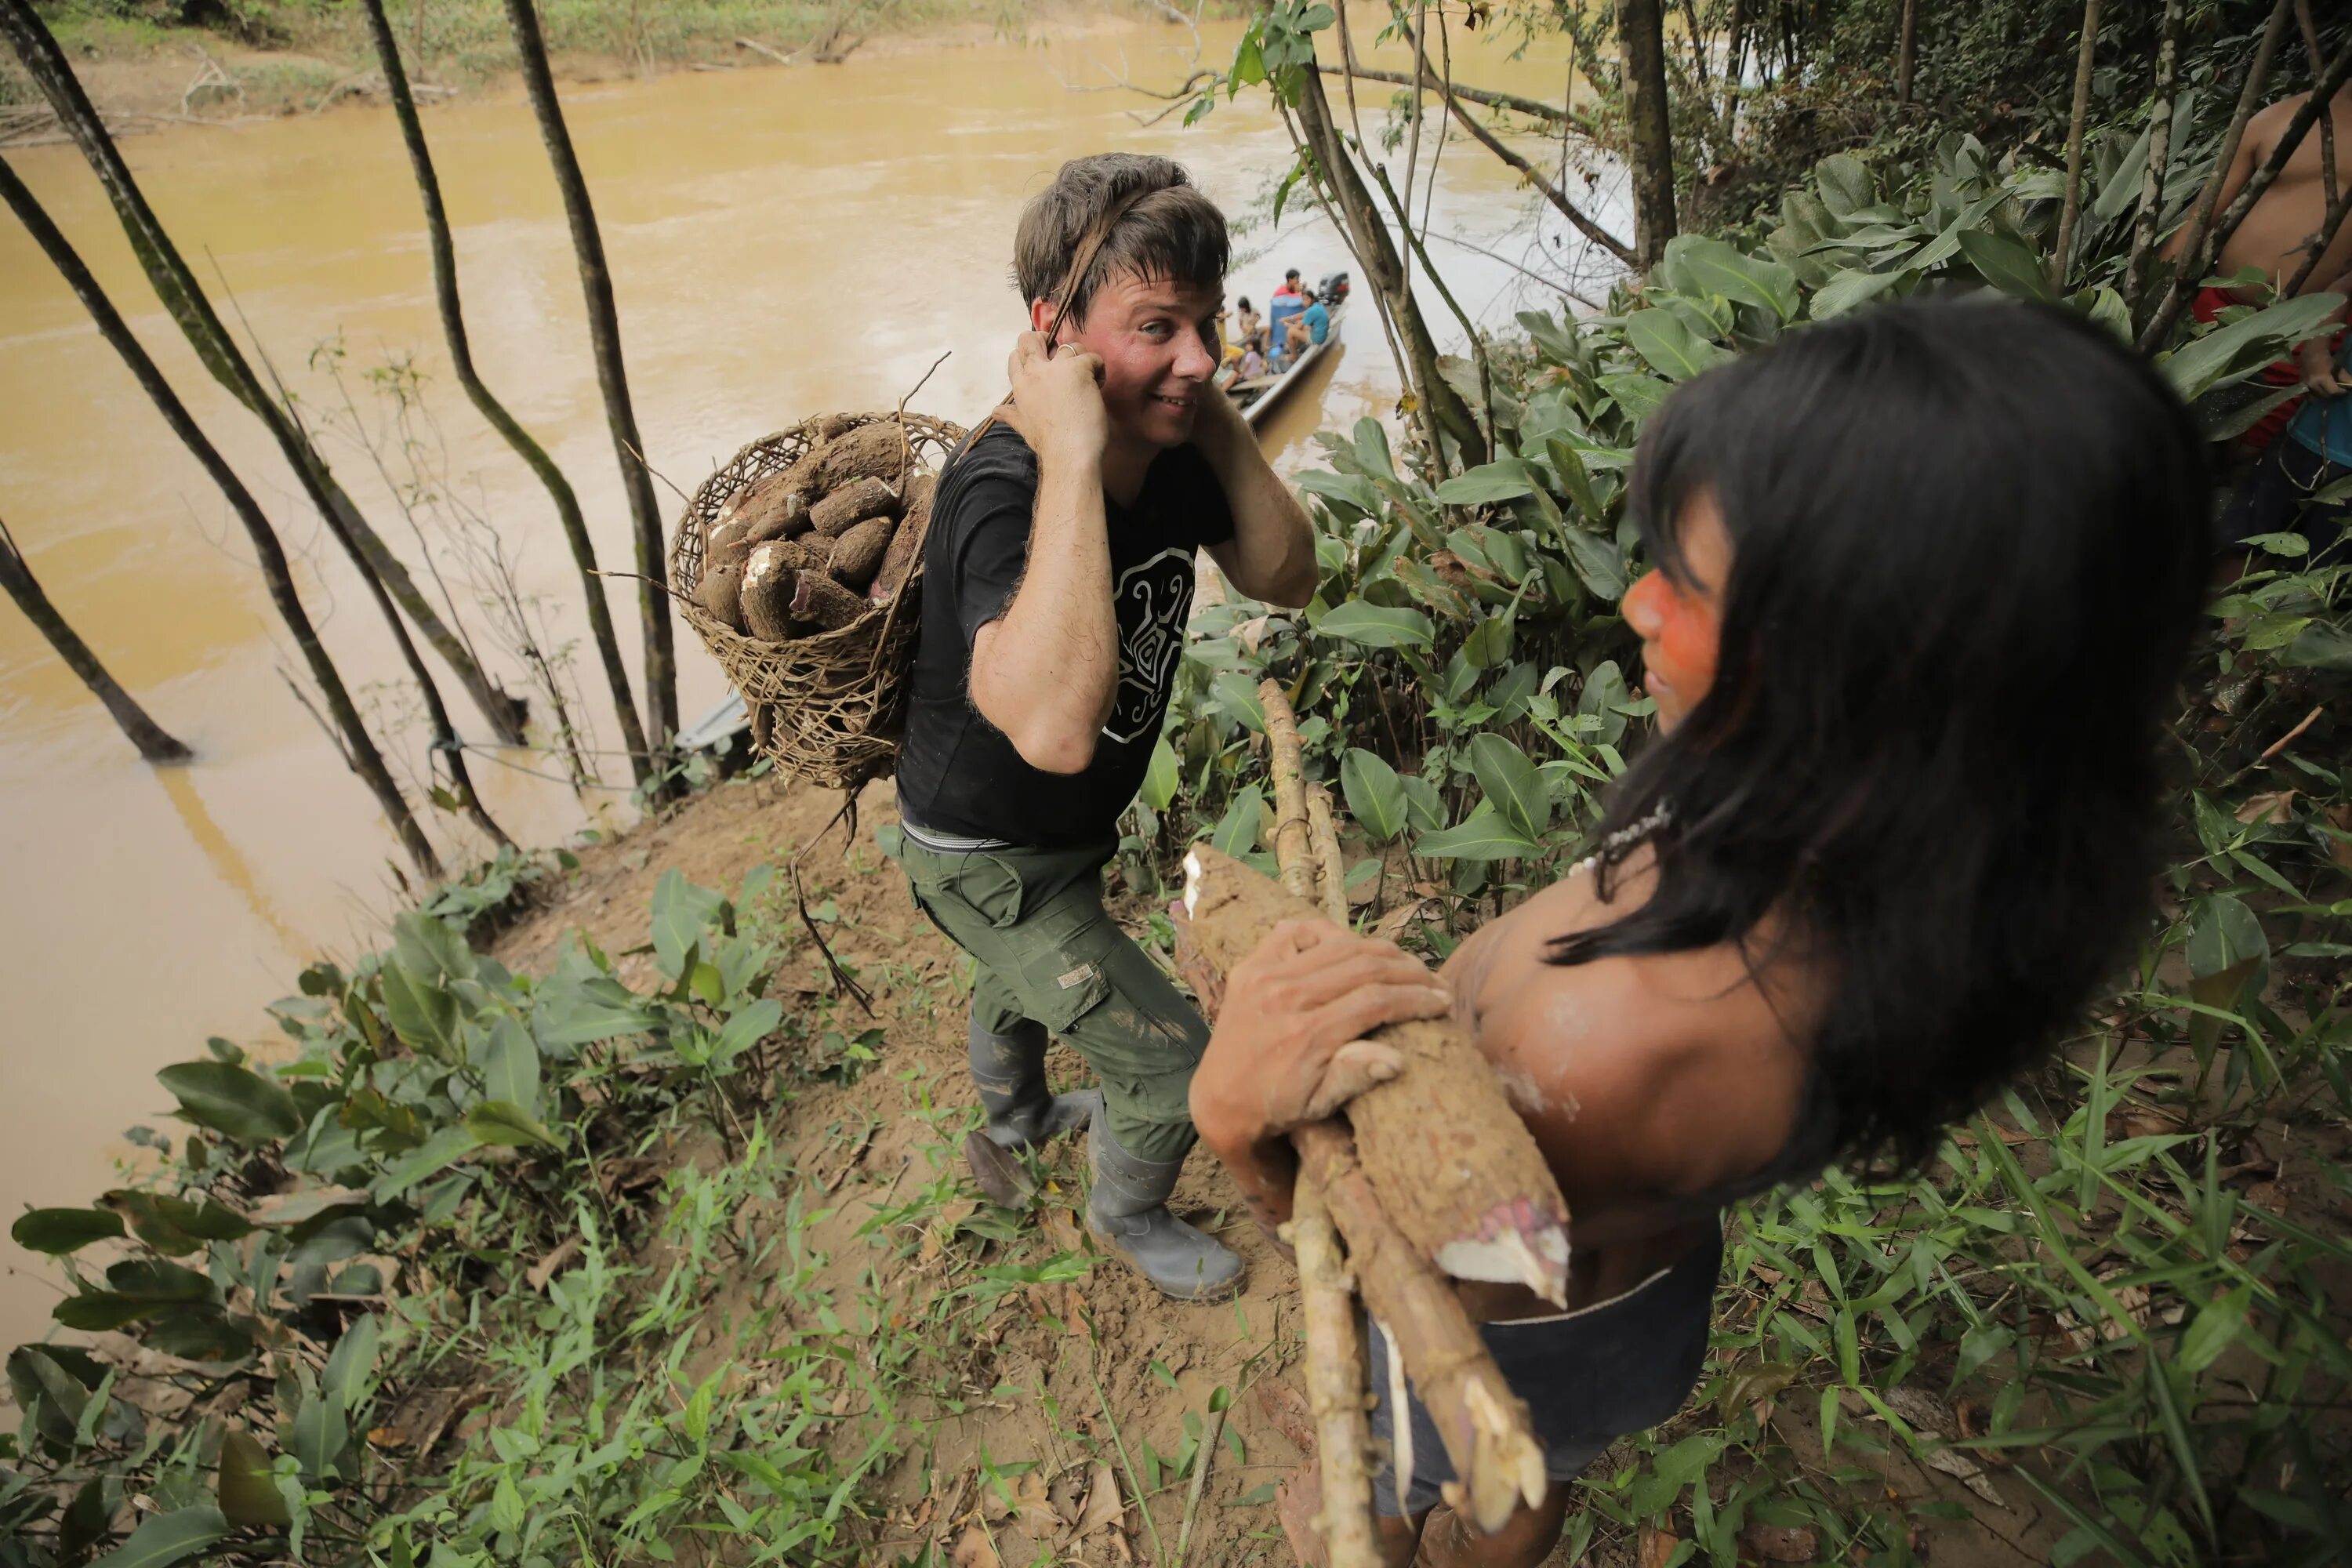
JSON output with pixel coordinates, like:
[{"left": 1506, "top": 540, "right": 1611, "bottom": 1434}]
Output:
[{"left": 694, "top": 414, "right": 934, "bottom": 642}]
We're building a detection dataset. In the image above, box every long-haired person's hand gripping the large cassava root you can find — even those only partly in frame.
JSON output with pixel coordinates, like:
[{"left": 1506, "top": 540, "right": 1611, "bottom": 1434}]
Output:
[{"left": 1192, "top": 919, "right": 1454, "bottom": 1163}]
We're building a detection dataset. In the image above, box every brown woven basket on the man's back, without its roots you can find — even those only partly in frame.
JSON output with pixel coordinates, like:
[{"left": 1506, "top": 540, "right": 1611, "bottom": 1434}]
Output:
[{"left": 670, "top": 414, "right": 964, "bottom": 792}]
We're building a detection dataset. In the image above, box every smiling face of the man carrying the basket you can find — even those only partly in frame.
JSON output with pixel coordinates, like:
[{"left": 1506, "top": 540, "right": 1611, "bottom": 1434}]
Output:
[{"left": 1033, "top": 273, "right": 1223, "bottom": 447}]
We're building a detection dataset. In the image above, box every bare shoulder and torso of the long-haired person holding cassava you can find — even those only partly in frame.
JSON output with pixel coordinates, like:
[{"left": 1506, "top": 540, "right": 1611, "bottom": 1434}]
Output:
[{"left": 1444, "top": 851, "right": 1816, "bottom": 1321}]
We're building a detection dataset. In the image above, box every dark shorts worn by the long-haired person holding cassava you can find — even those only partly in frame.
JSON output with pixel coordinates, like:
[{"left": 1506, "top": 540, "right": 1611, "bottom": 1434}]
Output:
[{"left": 1364, "top": 1232, "right": 1724, "bottom": 1514}]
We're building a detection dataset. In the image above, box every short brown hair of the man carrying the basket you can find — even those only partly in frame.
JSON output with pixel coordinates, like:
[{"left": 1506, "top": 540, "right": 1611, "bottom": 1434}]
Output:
[{"left": 1014, "top": 153, "right": 1232, "bottom": 327}]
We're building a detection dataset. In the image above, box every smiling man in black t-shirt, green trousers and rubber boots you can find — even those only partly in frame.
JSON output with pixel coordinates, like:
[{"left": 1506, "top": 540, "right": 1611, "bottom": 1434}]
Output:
[{"left": 896, "top": 153, "right": 1317, "bottom": 1300}]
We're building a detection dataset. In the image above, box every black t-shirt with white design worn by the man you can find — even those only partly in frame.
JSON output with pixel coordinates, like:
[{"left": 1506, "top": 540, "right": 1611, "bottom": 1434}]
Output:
[{"left": 898, "top": 426, "right": 1232, "bottom": 848}]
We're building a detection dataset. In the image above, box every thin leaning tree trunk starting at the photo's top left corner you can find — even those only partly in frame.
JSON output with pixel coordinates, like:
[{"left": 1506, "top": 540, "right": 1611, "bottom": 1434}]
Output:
[{"left": 0, "top": 0, "right": 524, "bottom": 746}]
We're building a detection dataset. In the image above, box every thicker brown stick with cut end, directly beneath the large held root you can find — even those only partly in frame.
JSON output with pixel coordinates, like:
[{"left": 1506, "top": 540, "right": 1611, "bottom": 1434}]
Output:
[{"left": 1291, "top": 1121, "right": 1545, "bottom": 1533}]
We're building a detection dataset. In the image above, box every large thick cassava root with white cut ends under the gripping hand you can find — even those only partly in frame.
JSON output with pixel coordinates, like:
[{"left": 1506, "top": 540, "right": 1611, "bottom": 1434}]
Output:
[{"left": 1183, "top": 844, "right": 1569, "bottom": 1305}]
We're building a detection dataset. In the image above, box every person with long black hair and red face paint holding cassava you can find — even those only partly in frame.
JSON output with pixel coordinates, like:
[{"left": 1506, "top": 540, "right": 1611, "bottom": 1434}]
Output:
[{"left": 1192, "top": 299, "right": 2209, "bottom": 1566}]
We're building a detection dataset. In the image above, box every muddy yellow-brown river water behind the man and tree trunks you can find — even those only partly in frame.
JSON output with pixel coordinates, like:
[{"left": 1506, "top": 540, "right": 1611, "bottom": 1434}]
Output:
[{"left": 0, "top": 12, "right": 1609, "bottom": 1347}]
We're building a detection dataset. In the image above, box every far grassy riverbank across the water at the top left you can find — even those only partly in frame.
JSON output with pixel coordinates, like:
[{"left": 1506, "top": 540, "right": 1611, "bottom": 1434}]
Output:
[{"left": 0, "top": 0, "right": 1216, "bottom": 146}]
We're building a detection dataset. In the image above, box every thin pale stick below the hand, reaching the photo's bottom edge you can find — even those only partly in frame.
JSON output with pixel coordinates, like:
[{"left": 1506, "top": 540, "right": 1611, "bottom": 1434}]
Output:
[{"left": 1284, "top": 1175, "right": 1381, "bottom": 1568}]
